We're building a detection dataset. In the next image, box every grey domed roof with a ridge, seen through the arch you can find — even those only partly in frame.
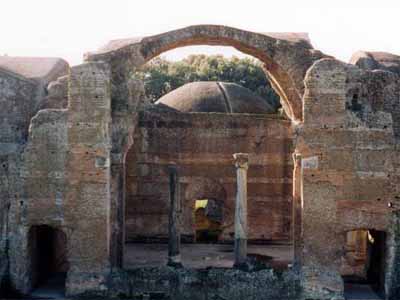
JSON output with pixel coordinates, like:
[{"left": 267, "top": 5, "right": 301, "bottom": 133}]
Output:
[{"left": 156, "top": 81, "right": 276, "bottom": 114}]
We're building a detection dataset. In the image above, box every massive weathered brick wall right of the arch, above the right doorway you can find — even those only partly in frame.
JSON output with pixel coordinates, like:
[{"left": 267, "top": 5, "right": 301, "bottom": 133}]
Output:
[{"left": 296, "top": 59, "right": 399, "bottom": 296}]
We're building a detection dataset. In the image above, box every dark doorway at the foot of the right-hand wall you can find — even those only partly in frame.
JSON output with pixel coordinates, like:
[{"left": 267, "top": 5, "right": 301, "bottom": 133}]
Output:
[{"left": 341, "top": 229, "right": 386, "bottom": 299}]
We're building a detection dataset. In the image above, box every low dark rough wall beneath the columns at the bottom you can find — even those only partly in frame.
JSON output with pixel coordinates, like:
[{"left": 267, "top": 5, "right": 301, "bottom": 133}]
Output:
[{"left": 107, "top": 267, "right": 300, "bottom": 300}]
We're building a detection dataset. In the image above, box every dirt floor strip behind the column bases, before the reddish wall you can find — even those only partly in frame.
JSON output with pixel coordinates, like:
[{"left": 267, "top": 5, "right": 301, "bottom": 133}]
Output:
[{"left": 124, "top": 243, "right": 293, "bottom": 269}]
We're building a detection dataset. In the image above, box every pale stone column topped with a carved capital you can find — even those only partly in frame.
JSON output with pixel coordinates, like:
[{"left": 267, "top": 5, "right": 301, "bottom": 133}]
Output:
[{"left": 233, "top": 153, "right": 249, "bottom": 267}]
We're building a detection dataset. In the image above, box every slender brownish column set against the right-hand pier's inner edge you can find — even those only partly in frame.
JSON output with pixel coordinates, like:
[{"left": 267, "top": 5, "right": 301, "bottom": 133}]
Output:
[{"left": 292, "top": 153, "right": 302, "bottom": 266}]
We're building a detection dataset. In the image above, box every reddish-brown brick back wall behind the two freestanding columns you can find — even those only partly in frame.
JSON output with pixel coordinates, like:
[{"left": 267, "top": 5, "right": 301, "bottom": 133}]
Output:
[{"left": 126, "top": 110, "right": 293, "bottom": 241}]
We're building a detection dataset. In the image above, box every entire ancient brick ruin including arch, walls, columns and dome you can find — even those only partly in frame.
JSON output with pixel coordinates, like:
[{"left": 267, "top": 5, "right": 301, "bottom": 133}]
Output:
[{"left": 0, "top": 25, "right": 400, "bottom": 299}]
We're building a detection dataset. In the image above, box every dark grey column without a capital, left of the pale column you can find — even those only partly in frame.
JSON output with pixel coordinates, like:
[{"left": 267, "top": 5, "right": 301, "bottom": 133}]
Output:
[{"left": 168, "top": 165, "right": 182, "bottom": 267}]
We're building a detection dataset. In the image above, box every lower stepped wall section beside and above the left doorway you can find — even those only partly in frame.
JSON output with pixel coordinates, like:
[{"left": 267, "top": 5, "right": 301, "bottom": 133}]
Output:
[{"left": 9, "top": 110, "right": 67, "bottom": 293}]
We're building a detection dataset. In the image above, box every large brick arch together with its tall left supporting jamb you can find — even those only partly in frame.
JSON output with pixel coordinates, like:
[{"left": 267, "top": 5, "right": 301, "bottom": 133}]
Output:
[{"left": 85, "top": 25, "right": 325, "bottom": 267}]
